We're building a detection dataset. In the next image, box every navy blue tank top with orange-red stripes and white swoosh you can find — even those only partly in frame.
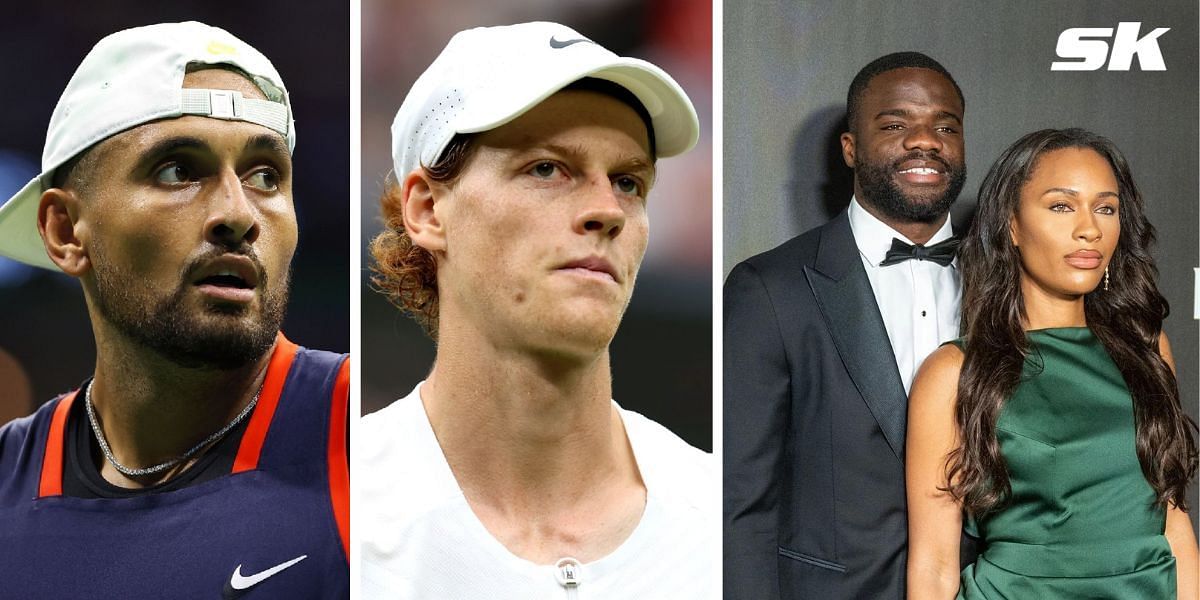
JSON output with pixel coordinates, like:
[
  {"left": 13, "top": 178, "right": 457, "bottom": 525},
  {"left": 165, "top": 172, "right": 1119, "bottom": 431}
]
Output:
[{"left": 0, "top": 334, "right": 349, "bottom": 599}]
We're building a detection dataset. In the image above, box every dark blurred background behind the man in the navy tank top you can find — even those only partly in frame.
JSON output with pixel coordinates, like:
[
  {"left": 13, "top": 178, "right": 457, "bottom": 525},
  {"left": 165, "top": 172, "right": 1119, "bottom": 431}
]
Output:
[{"left": 0, "top": 0, "right": 350, "bottom": 422}]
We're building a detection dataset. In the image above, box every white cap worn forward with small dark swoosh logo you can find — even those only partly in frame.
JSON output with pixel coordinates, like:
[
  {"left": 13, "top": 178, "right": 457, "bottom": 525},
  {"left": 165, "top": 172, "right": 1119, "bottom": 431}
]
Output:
[{"left": 391, "top": 23, "right": 700, "bottom": 179}]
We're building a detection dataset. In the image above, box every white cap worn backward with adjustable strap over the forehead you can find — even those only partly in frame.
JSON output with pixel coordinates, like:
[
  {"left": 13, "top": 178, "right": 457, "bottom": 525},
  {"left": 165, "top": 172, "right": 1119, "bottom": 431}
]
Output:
[{"left": 0, "top": 22, "right": 296, "bottom": 269}]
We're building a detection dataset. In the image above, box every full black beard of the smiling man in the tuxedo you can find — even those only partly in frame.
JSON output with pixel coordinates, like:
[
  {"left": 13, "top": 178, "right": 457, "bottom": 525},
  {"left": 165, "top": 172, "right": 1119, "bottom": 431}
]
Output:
[{"left": 854, "top": 151, "right": 967, "bottom": 223}]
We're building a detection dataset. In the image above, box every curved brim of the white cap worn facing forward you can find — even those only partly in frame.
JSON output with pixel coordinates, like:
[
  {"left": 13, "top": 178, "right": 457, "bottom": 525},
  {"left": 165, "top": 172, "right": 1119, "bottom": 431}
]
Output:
[{"left": 456, "top": 56, "right": 700, "bottom": 157}]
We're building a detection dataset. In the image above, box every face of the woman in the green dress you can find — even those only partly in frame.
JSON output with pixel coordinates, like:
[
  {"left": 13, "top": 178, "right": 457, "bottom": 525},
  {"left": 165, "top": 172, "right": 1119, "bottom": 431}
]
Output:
[{"left": 1012, "top": 148, "right": 1121, "bottom": 299}]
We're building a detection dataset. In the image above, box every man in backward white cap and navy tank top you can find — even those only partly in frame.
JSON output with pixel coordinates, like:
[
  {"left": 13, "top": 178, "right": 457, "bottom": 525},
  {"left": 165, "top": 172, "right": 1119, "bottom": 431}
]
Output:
[{"left": 0, "top": 23, "right": 349, "bottom": 598}]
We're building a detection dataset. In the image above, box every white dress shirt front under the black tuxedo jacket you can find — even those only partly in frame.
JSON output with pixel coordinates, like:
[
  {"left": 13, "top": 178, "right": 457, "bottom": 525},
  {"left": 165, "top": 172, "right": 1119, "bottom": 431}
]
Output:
[{"left": 850, "top": 198, "right": 962, "bottom": 394}]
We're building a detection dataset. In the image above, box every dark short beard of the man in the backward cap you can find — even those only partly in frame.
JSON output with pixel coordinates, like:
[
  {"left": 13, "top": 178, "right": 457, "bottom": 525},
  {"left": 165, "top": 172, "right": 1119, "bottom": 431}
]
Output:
[{"left": 92, "top": 246, "right": 292, "bottom": 370}]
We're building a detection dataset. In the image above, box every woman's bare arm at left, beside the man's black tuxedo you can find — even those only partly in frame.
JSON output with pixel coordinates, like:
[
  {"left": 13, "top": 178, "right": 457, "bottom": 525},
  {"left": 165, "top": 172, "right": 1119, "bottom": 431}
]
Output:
[{"left": 905, "top": 344, "right": 962, "bottom": 600}]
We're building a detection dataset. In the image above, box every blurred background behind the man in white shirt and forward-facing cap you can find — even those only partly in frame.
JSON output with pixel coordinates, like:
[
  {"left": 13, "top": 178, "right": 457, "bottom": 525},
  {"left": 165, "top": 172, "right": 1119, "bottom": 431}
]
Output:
[{"left": 360, "top": 0, "right": 713, "bottom": 450}]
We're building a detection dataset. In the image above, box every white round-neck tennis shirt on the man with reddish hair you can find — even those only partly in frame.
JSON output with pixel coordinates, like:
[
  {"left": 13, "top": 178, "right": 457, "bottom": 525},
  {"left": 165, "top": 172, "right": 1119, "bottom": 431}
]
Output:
[{"left": 354, "top": 384, "right": 720, "bottom": 600}]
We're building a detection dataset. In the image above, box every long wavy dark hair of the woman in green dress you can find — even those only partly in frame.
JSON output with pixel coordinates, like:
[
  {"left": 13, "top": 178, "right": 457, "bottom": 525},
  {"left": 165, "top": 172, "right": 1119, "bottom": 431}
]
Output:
[{"left": 947, "top": 128, "right": 1196, "bottom": 515}]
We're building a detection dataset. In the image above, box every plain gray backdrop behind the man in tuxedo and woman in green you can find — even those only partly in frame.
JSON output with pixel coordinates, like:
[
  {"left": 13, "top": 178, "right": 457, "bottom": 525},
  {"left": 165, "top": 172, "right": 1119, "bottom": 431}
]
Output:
[{"left": 724, "top": 0, "right": 1200, "bottom": 506}]
